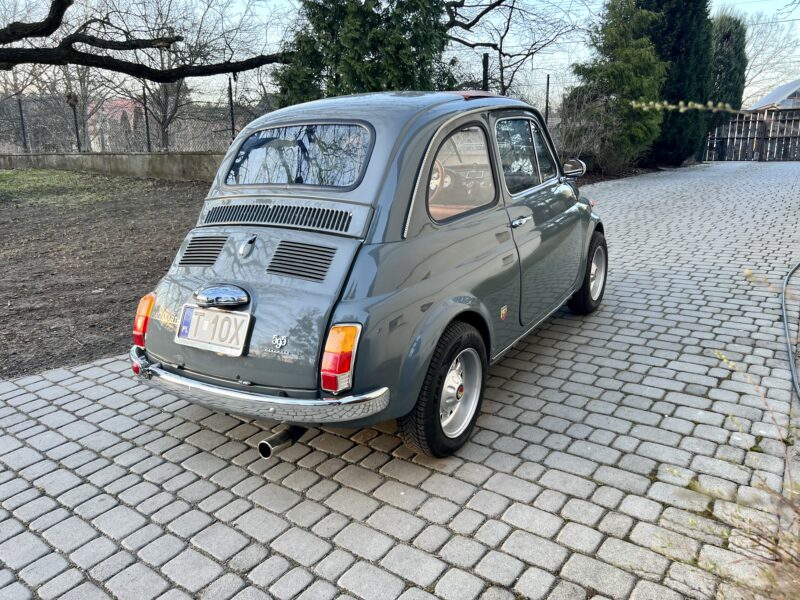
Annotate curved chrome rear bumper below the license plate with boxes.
[130,346,389,425]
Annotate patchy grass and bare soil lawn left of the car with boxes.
[0,170,208,379]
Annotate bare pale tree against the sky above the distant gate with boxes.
[742,12,800,106]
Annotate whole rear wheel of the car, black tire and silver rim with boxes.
[399,321,488,457]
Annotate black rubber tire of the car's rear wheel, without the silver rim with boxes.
[398,321,488,458]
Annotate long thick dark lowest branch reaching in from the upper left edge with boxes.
[0,46,290,83]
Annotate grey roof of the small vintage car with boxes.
[247,91,529,130]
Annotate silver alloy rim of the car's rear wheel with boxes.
[439,348,483,438]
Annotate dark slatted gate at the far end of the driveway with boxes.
[704,108,800,161]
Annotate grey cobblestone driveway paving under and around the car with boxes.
[0,163,800,600]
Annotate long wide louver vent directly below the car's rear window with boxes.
[203,204,353,233]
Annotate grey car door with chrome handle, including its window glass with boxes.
[495,113,583,325]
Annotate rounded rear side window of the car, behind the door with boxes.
[428,125,495,221]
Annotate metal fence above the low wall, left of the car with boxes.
[0,88,271,154]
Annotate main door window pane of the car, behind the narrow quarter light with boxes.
[496,119,541,194]
